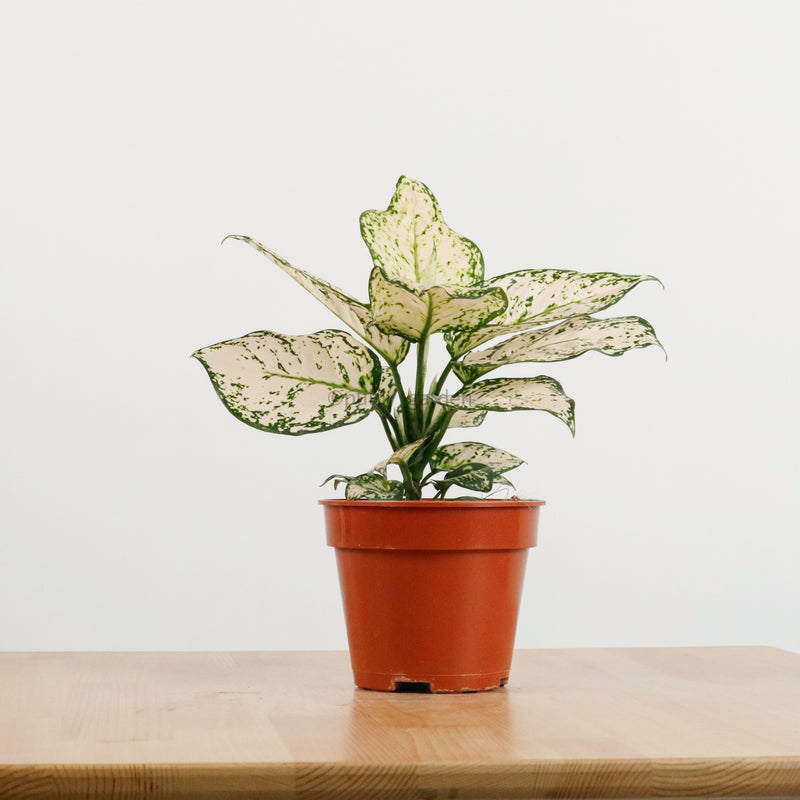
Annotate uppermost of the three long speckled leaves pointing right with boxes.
[445,269,658,355]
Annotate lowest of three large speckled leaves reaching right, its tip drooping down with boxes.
[431,375,575,433]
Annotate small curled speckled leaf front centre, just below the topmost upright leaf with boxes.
[369,267,506,341]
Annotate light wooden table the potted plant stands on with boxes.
[0,647,800,800]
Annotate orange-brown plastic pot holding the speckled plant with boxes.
[320,500,544,692]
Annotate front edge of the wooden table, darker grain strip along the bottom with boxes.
[0,754,800,800]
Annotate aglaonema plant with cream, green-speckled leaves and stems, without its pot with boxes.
[194,177,660,500]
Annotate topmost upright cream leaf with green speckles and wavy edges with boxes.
[361,176,483,287]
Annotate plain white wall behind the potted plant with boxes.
[0,0,800,651]
